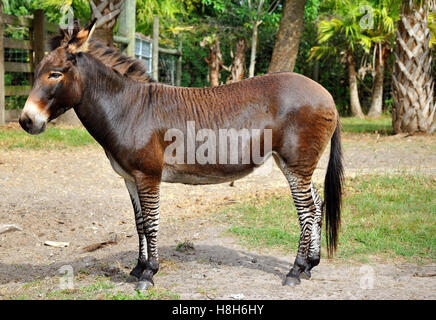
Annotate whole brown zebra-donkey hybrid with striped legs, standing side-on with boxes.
[19,24,343,289]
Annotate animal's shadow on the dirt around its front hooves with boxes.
[0,245,290,284]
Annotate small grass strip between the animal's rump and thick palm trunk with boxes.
[341,116,392,134]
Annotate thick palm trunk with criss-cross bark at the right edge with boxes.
[392,2,436,133]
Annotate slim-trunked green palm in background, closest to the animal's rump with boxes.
[309,0,372,118]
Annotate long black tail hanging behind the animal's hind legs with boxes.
[324,118,344,257]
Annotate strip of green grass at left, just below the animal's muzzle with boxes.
[0,126,96,149]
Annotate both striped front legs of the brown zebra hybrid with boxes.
[126,179,159,290]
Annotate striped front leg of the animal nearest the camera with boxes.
[137,180,160,290]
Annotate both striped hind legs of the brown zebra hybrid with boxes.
[275,155,322,285]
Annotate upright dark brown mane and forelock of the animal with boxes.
[50,22,155,82]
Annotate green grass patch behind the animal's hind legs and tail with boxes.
[224,175,436,262]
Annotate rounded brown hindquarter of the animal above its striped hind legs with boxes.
[275,75,338,176]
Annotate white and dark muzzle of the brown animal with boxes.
[19,98,49,134]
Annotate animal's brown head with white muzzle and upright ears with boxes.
[19,20,95,134]
